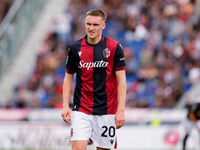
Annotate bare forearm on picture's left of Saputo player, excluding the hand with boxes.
[63,75,73,107]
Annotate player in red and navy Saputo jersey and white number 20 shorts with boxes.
[61,9,126,150]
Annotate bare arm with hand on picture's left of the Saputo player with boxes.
[61,72,74,123]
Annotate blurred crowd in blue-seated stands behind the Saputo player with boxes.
[6,0,200,108]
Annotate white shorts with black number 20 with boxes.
[70,111,117,149]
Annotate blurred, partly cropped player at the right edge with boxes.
[183,102,200,150]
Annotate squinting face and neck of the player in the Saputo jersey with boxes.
[85,16,106,44]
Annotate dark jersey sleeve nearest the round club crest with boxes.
[114,43,126,71]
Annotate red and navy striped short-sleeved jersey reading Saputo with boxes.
[66,36,126,115]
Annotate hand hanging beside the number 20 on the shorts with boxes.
[115,110,125,129]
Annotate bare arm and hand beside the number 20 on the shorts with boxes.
[115,70,126,129]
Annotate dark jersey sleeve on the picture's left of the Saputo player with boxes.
[66,46,76,74]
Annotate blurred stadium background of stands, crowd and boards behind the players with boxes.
[0,0,200,150]
